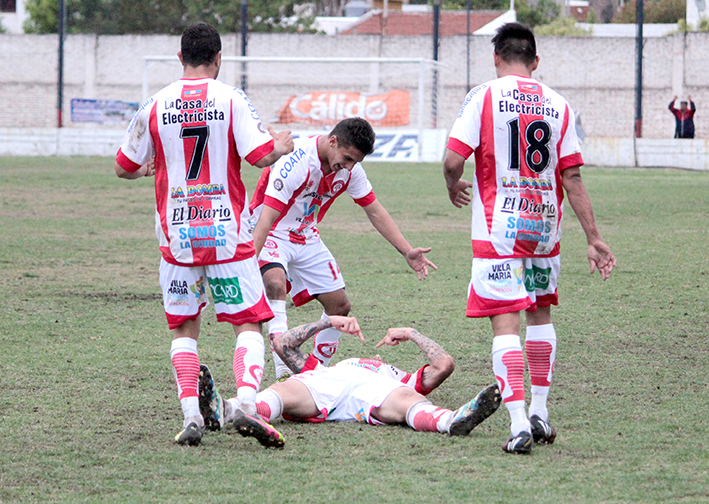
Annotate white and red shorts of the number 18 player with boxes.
[466,255,561,317]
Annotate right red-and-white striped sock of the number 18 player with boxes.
[524,324,556,420]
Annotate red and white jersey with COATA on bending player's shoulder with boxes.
[251,136,376,244]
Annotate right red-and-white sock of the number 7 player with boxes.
[233,331,265,415]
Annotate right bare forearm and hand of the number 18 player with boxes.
[561,166,616,280]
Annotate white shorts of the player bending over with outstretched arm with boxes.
[259,236,345,306]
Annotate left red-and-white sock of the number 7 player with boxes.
[170,338,204,426]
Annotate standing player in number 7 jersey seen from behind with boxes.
[115,23,293,445]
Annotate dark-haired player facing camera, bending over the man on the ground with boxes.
[251,117,436,379]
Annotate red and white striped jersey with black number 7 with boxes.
[116,78,274,266]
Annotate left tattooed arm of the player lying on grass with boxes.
[269,315,364,373]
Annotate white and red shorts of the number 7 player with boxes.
[160,257,273,329]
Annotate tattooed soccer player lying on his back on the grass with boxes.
[199,316,501,445]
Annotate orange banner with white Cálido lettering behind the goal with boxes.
[278,89,409,127]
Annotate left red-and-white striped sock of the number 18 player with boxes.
[492,334,531,436]
